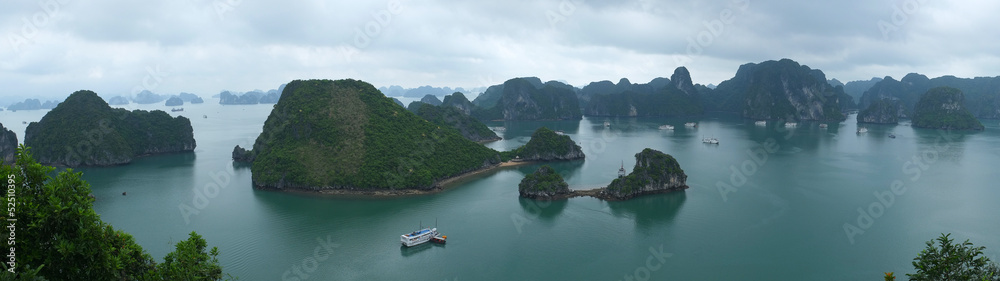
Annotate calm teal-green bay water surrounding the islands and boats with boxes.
[0,100,1000,280]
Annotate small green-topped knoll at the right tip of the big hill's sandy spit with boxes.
[500,127,586,161]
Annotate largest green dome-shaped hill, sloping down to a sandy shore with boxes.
[235,79,500,190]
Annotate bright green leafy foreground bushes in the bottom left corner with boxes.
[0,146,223,281]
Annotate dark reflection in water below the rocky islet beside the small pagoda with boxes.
[607,191,687,231]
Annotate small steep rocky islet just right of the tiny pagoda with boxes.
[601,148,688,200]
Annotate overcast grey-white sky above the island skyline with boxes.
[0,0,1000,105]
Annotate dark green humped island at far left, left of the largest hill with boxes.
[24,91,196,167]
